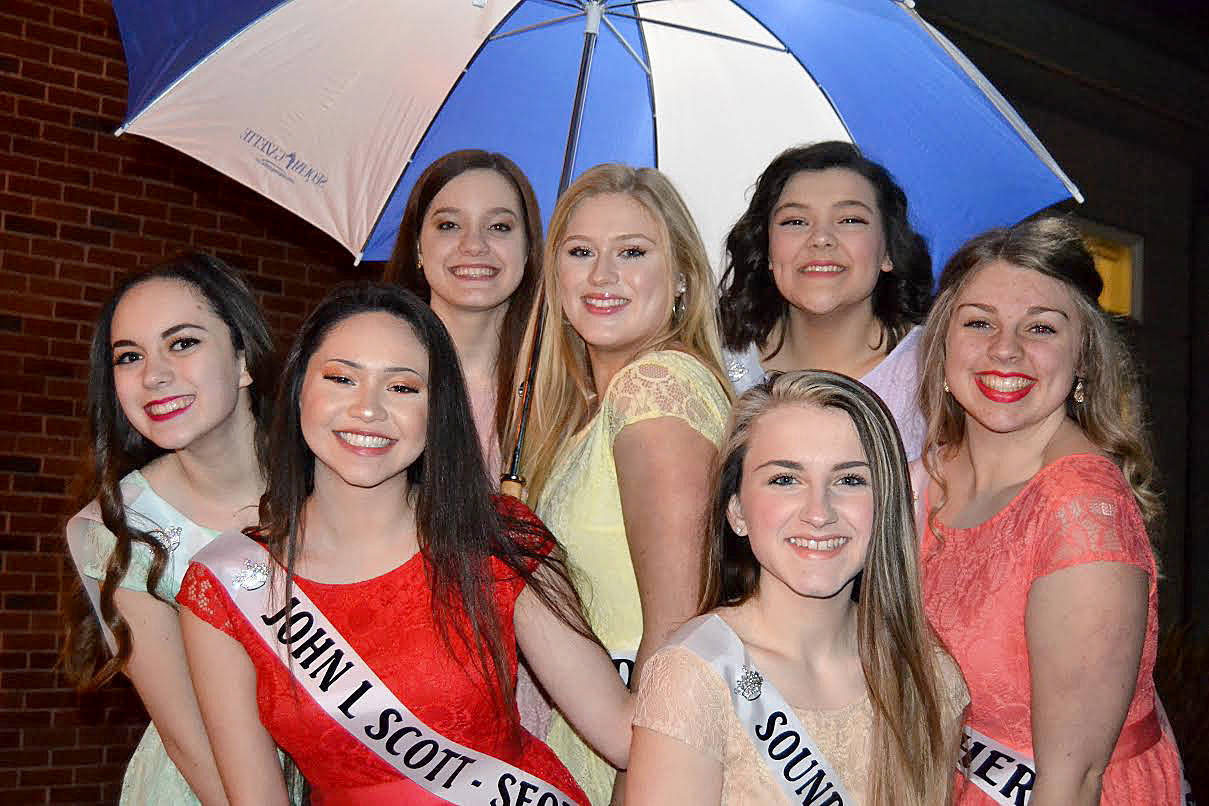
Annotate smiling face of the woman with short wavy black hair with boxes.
[768,168,891,317]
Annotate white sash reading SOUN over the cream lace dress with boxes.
[669,614,856,806]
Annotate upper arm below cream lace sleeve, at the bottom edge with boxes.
[625,725,722,806]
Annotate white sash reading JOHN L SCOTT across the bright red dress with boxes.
[193,532,575,806]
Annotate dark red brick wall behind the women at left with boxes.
[0,0,374,804]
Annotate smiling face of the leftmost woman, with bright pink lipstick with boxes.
[110,279,251,451]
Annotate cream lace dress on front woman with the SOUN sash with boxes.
[634,646,970,806]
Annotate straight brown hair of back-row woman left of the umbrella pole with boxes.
[382,149,542,456]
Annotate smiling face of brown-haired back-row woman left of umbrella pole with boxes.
[420,168,528,314]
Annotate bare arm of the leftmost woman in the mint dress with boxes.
[114,587,227,806]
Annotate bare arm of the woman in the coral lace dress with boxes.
[1025,562,1150,806]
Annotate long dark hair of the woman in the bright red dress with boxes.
[259,283,595,736]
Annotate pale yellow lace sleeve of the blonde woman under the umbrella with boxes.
[603,350,729,443]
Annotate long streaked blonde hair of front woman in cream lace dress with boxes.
[700,370,960,806]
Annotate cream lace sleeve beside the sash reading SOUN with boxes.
[634,646,733,761]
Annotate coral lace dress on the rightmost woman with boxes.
[921,454,1182,806]
